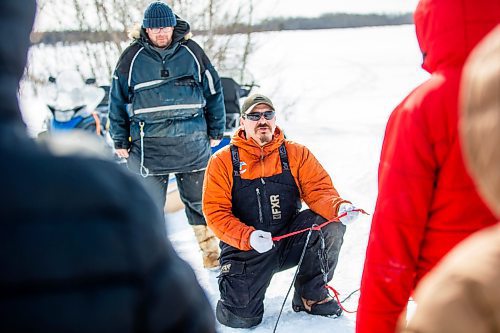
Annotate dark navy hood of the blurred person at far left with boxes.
[0,0,36,123]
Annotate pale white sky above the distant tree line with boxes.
[254,0,418,20]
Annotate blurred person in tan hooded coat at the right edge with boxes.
[400,25,500,333]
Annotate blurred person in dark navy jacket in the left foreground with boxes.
[0,0,215,333]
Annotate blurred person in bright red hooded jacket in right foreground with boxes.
[356,0,500,333]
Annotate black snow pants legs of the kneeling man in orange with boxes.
[216,209,346,328]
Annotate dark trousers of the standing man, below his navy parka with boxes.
[145,170,207,225]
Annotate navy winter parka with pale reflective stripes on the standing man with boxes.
[109,18,225,175]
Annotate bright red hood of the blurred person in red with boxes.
[414,0,500,73]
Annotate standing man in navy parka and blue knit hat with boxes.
[109,1,225,268]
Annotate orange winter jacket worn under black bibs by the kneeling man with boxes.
[203,127,348,250]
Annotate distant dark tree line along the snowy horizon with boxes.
[31,13,413,45]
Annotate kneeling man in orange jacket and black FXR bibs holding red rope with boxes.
[203,94,358,328]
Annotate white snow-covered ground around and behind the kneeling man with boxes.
[20,26,427,333]
